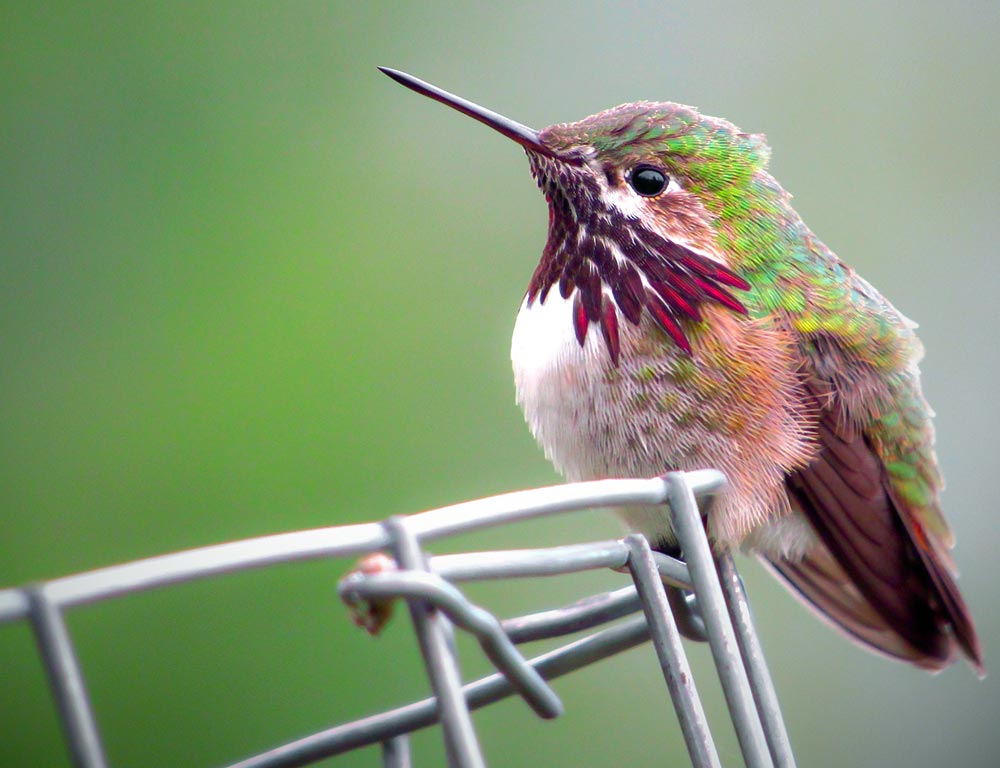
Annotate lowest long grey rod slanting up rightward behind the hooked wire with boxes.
[223,616,649,768]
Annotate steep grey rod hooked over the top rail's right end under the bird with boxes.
[665,472,771,768]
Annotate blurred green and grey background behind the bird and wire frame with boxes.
[0,0,1000,768]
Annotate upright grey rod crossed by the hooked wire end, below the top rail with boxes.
[385,517,486,768]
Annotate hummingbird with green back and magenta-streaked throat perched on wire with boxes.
[380,67,983,674]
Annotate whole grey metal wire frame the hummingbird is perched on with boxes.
[0,470,795,768]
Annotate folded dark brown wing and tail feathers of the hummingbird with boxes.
[774,384,982,672]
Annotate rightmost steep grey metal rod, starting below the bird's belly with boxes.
[715,552,795,768]
